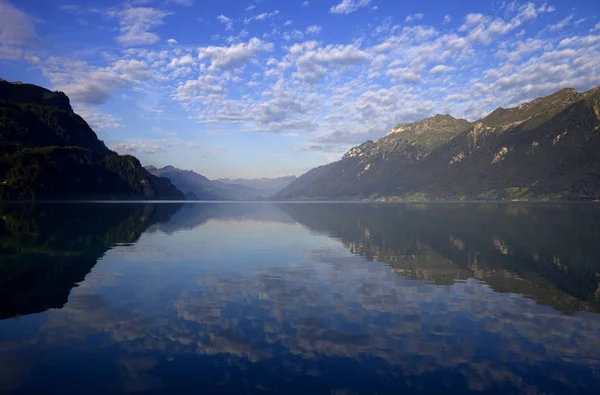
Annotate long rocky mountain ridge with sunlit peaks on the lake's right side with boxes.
[275,87,600,200]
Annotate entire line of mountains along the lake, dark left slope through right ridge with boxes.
[0,79,600,201]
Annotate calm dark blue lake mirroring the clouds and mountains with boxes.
[0,204,600,394]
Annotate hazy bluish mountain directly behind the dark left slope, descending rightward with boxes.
[146,166,260,200]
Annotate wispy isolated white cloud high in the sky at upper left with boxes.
[109,7,170,46]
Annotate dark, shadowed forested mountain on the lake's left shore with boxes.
[0,79,184,200]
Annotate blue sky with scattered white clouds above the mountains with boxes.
[0,0,600,179]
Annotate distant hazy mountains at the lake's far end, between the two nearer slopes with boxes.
[145,166,296,200]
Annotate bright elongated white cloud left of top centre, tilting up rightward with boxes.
[198,38,273,71]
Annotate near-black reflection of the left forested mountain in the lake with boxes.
[0,204,181,319]
